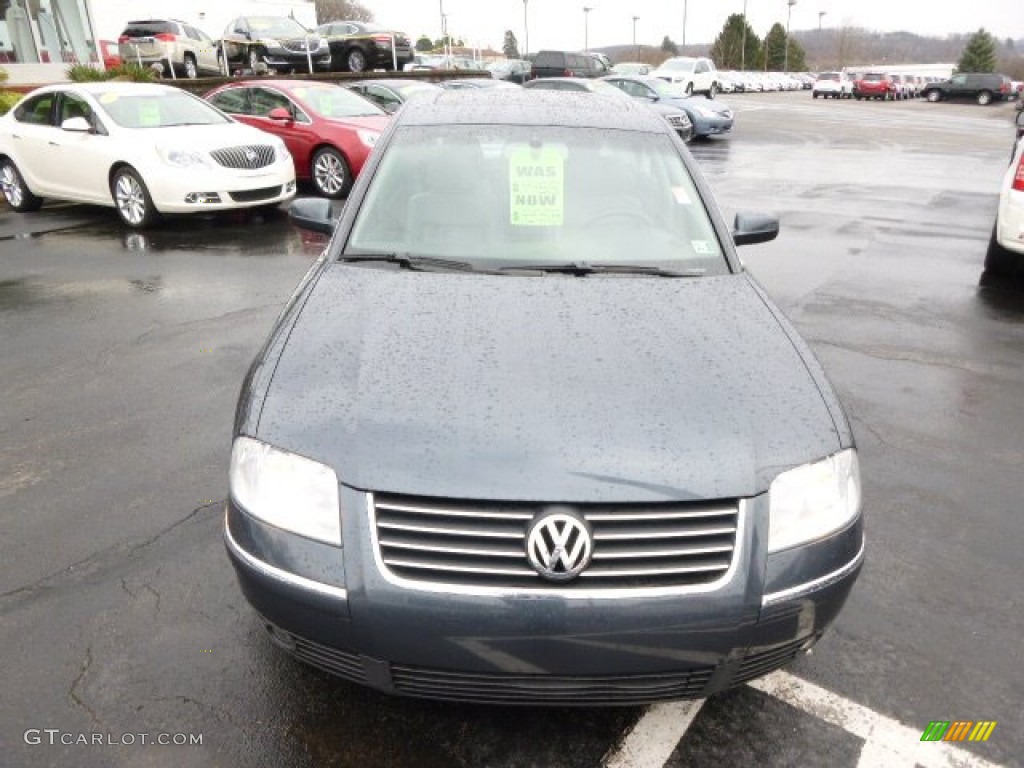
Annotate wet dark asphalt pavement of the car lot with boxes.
[0,93,1024,768]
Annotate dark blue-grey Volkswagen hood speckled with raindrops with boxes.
[257,264,841,502]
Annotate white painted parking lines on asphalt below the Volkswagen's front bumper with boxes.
[602,672,1004,768]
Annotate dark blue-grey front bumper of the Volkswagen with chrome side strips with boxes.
[224,487,864,706]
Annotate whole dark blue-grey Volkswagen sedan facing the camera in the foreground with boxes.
[224,91,863,705]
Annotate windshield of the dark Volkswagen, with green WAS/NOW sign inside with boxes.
[342,125,728,274]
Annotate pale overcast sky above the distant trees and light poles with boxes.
[362,0,1024,50]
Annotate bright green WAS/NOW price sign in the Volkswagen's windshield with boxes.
[509,146,565,226]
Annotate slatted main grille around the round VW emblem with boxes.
[371,496,740,593]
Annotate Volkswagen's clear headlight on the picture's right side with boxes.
[768,449,860,552]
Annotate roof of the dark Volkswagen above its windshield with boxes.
[397,88,670,133]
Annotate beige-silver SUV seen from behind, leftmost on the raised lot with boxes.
[118,18,222,78]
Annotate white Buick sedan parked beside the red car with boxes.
[0,82,295,229]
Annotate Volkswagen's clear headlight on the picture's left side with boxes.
[229,437,341,546]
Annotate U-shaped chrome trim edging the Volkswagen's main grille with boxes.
[366,492,749,600]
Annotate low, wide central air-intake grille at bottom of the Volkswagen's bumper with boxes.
[391,664,715,706]
